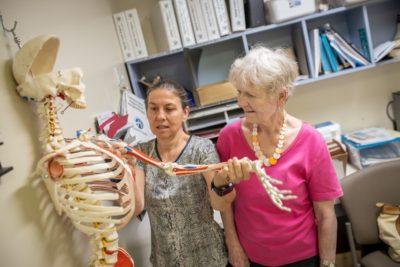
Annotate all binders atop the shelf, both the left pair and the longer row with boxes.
[114,0,266,56]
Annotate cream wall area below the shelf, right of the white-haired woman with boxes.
[287,63,400,132]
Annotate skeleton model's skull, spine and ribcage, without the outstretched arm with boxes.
[13,36,134,267]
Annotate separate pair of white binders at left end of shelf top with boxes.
[113,8,148,62]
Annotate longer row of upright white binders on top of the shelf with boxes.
[151,0,241,52]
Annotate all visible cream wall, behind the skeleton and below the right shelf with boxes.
[0,0,400,267]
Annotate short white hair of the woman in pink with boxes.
[229,46,298,96]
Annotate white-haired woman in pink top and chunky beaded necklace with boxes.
[213,47,343,267]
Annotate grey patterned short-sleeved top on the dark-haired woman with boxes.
[138,136,228,267]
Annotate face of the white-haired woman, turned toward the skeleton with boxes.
[237,87,278,123]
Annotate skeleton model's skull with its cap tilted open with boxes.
[13,35,86,108]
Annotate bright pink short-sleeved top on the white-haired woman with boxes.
[217,120,343,266]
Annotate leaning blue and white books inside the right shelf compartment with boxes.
[310,24,370,77]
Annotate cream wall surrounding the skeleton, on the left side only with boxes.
[0,0,150,267]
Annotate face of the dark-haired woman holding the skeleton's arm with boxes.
[147,89,189,139]
